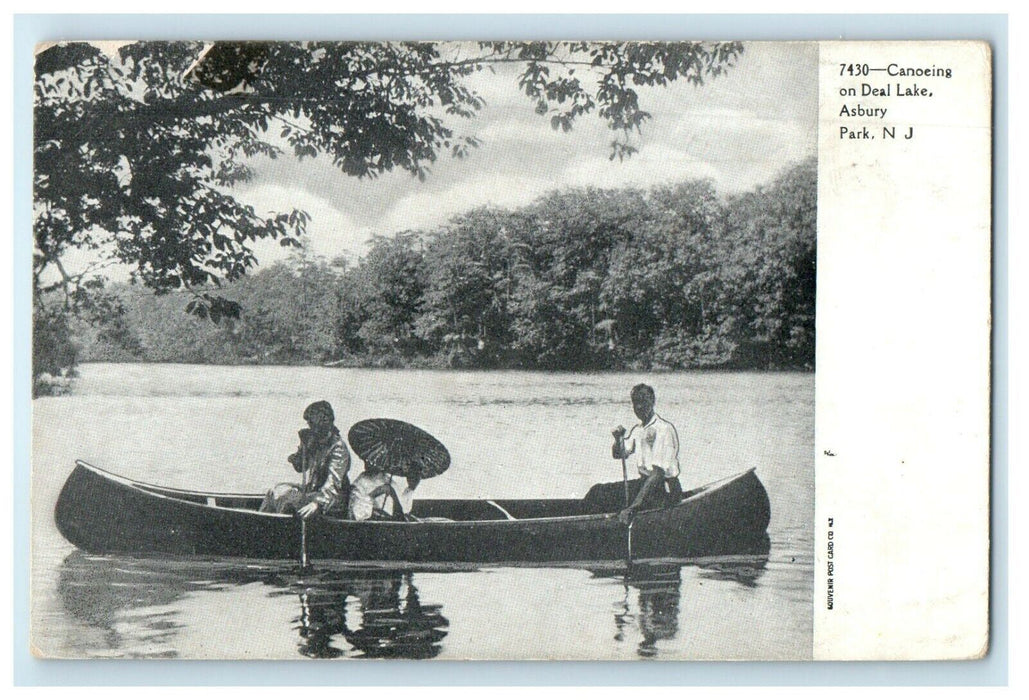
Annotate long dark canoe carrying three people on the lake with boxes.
[55,461,770,565]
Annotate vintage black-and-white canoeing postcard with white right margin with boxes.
[31,41,992,660]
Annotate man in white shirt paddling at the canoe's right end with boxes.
[611,384,682,523]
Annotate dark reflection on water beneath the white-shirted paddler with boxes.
[594,556,768,658]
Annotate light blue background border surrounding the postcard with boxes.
[12,14,1008,686]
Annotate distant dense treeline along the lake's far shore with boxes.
[75,160,817,370]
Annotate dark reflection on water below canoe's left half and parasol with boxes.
[58,551,450,659]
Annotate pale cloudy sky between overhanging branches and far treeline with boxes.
[235,42,818,265]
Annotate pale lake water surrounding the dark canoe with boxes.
[31,364,814,659]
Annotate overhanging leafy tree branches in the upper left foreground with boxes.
[33,41,742,382]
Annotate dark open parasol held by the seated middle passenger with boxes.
[347,418,450,479]
